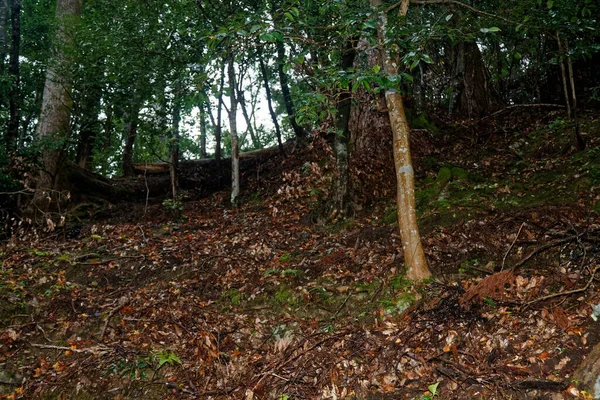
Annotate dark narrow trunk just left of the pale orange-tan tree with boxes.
[330,38,356,219]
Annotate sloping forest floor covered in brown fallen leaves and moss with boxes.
[0,108,600,400]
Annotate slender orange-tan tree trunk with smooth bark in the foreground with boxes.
[370,0,431,280]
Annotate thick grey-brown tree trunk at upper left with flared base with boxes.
[33,0,81,216]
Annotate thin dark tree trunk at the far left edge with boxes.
[6,0,21,151]
